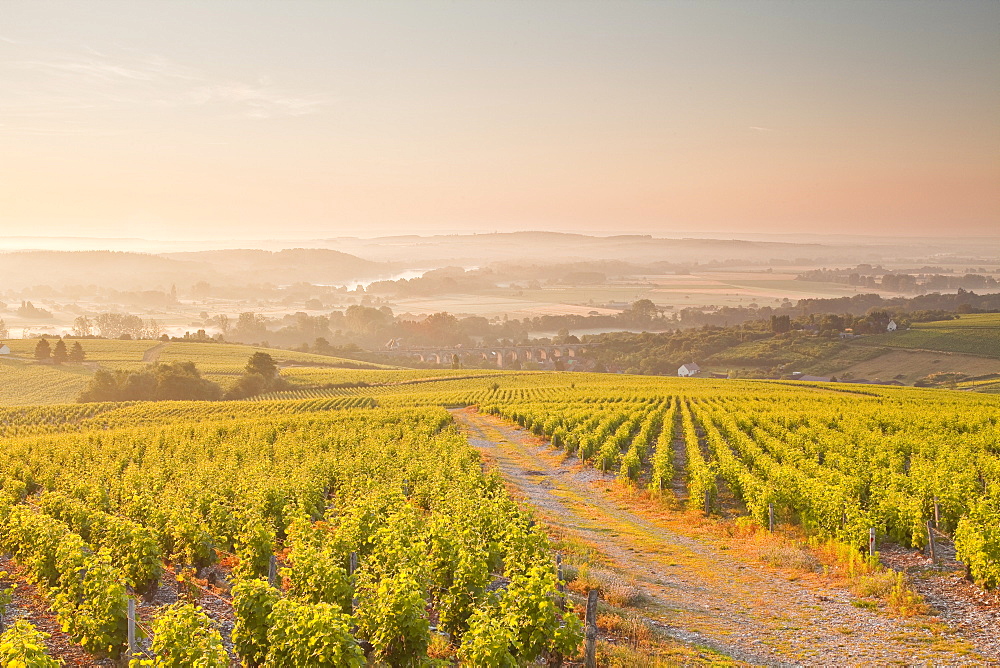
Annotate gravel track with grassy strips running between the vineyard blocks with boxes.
[452,409,989,665]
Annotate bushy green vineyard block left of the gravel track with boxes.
[0,407,581,666]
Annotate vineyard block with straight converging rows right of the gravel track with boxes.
[482,382,1000,587]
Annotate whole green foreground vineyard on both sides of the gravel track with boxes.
[0,370,1000,666]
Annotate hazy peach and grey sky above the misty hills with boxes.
[0,0,1000,239]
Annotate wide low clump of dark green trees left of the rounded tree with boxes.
[77,362,222,403]
